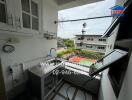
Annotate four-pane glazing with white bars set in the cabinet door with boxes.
[21,0,39,30]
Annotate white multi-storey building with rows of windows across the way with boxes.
[75,35,108,53]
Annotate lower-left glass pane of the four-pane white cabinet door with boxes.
[22,13,31,28]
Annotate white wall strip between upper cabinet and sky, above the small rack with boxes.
[42,0,58,33]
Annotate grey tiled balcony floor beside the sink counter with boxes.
[50,83,93,100]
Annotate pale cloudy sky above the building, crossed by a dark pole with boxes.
[58,0,115,38]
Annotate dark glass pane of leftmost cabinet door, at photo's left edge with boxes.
[0,3,6,23]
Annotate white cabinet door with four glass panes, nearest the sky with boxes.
[14,0,40,34]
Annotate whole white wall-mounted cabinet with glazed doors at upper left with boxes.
[0,0,41,34]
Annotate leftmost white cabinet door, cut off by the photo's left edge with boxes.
[0,0,14,31]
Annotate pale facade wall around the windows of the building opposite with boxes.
[75,36,108,53]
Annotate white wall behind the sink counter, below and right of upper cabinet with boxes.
[0,0,58,95]
